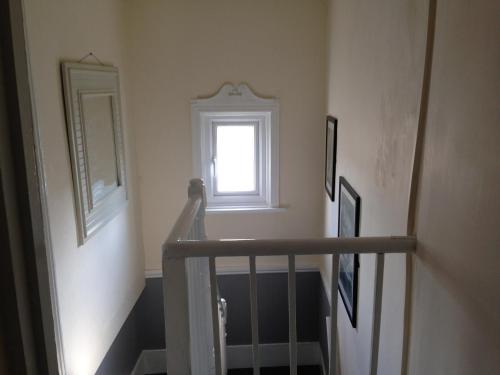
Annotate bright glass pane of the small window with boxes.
[216,125,256,193]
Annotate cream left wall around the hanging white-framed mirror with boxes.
[24,0,144,375]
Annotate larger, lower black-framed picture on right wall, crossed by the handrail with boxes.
[338,177,361,328]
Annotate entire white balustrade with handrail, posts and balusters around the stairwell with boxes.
[163,179,416,375]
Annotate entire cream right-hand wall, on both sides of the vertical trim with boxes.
[323,0,500,375]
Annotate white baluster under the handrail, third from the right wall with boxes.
[288,255,297,375]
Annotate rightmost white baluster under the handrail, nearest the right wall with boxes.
[370,253,384,375]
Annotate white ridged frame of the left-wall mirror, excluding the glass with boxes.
[61,62,127,246]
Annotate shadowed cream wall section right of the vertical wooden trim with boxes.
[410,0,500,375]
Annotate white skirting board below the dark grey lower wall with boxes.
[131,342,325,375]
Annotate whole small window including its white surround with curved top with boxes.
[191,84,278,210]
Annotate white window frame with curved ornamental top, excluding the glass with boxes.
[191,84,279,211]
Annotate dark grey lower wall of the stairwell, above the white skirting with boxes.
[97,271,330,375]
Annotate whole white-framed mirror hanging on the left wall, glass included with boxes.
[61,62,127,245]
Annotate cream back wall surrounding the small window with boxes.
[126,0,326,271]
